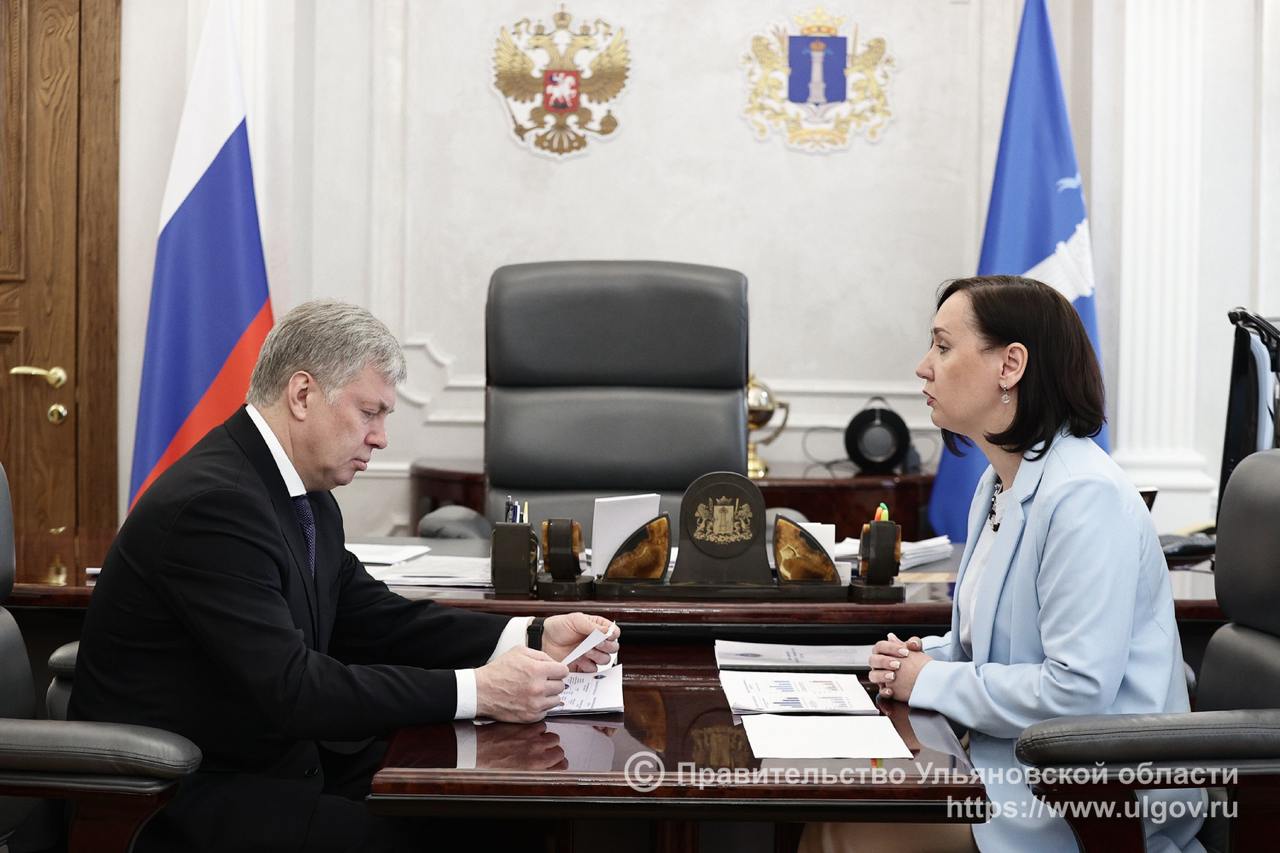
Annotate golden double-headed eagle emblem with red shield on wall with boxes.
[493,6,631,156]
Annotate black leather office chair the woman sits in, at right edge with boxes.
[1018,451,1280,853]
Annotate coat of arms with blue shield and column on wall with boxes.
[742,8,893,152]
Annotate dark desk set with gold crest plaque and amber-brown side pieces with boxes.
[596,471,849,601]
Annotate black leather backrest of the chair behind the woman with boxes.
[1196,450,1280,711]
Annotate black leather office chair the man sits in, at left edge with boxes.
[0,467,201,853]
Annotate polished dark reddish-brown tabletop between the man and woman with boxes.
[370,645,986,822]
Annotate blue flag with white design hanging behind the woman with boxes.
[929,0,1110,542]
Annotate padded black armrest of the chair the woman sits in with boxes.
[1015,708,1280,775]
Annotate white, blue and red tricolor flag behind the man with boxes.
[129,0,271,508]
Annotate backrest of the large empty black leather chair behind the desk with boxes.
[485,261,748,535]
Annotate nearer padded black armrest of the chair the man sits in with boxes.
[0,720,202,779]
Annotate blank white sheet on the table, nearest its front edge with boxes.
[742,713,911,758]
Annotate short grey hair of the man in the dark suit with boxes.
[247,300,406,409]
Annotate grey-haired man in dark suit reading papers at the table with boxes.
[69,301,617,850]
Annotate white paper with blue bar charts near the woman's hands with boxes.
[721,671,879,713]
